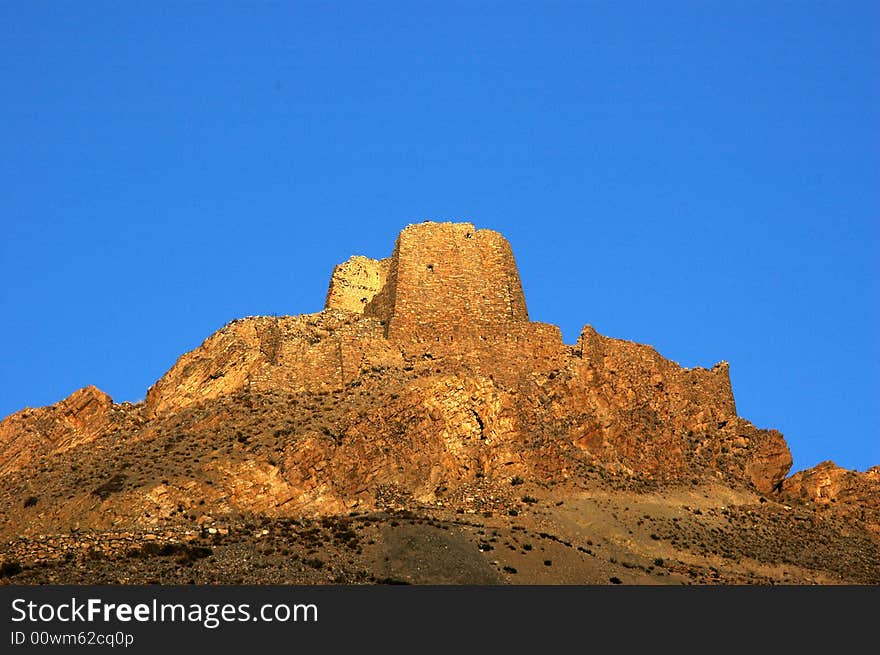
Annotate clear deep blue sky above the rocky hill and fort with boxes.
[0,0,880,469]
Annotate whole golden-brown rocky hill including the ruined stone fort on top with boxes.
[0,222,880,583]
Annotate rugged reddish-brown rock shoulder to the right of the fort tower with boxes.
[554,326,792,492]
